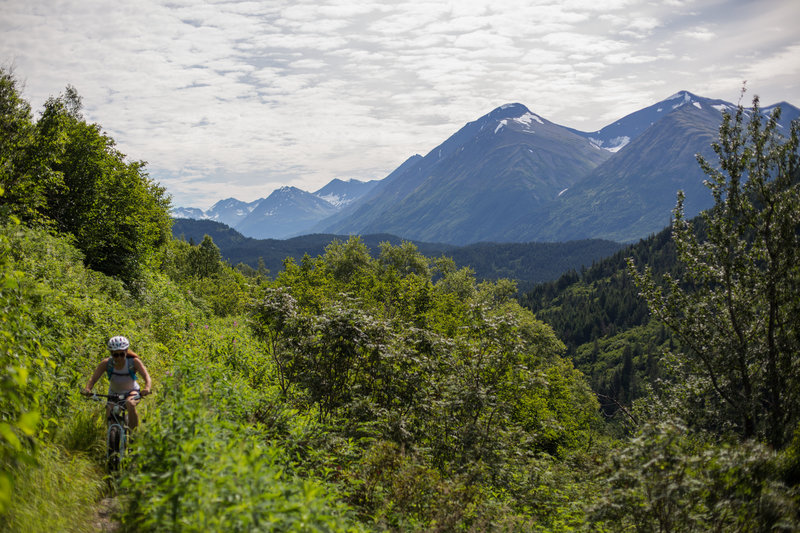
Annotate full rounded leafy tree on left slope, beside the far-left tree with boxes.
[37,87,171,282]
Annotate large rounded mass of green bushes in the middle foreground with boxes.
[251,238,598,530]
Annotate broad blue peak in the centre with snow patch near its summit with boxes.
[315,104,611,244]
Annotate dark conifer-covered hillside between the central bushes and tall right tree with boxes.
[520,224,684,416]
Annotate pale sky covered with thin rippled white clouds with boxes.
[0,0,800,209]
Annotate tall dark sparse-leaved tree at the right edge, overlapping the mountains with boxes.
[629,93,800,447]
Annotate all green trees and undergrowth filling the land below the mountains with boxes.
[0,67,800,532]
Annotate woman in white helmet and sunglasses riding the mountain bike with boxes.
[82,336,152,429]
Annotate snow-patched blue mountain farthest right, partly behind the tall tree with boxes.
[516,91,800,242]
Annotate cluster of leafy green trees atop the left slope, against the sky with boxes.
[0,70,171,284]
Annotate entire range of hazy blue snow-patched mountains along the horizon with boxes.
[174,91,800,245]
